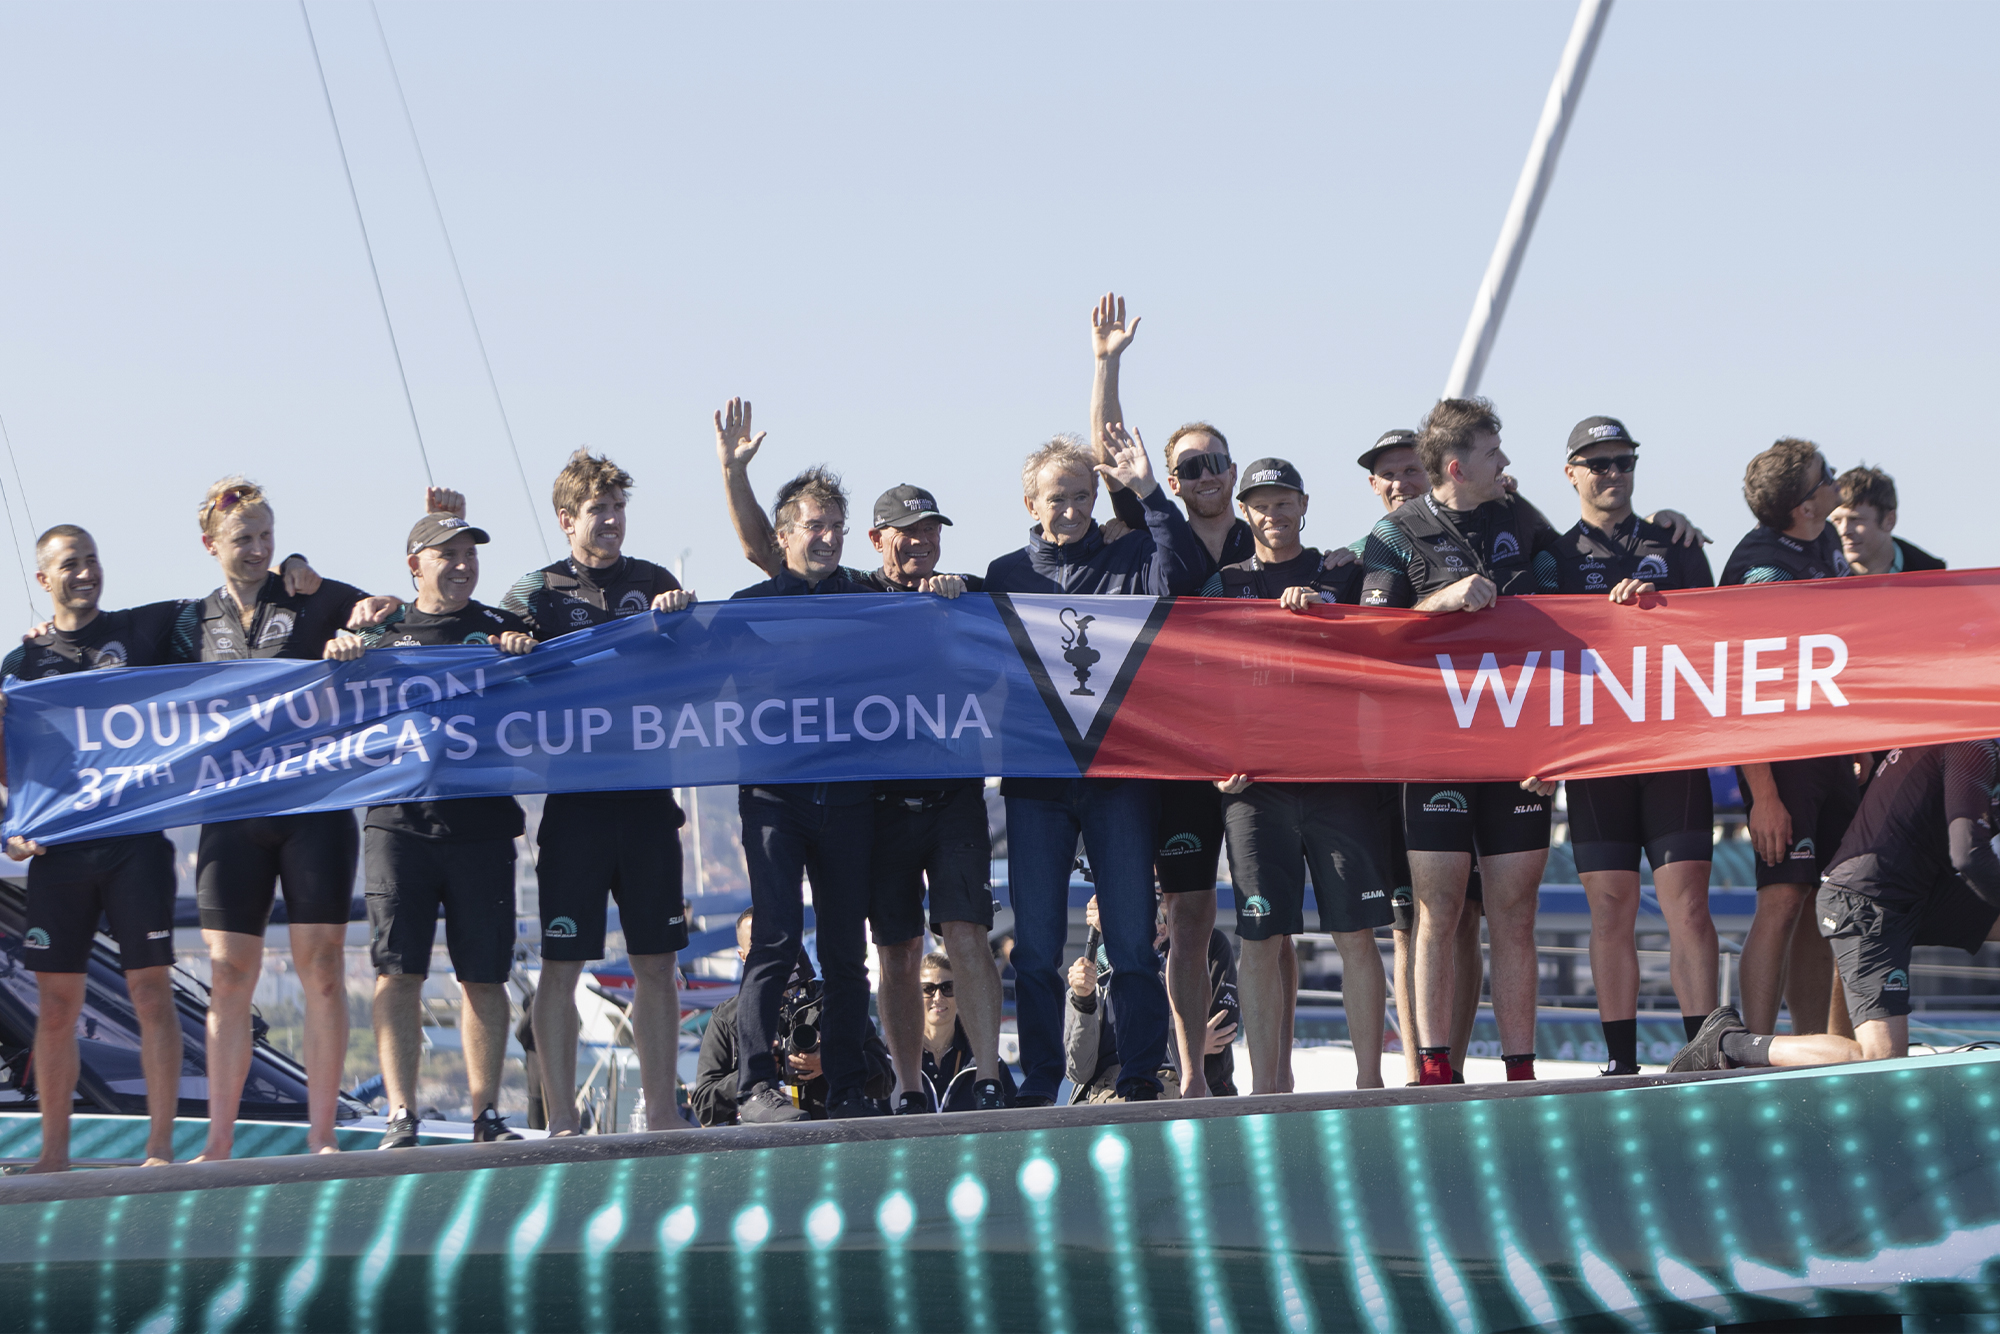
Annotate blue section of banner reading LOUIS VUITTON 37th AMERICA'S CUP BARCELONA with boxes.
[6,594,1078,844]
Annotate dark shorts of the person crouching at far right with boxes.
[1814,858,2000,1024]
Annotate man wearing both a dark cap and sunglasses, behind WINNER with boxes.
[1556,416,1716,1074]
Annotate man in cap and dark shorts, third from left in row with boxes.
[326,512,540,1148]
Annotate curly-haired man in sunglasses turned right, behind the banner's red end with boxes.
[1722,438,1860,1034]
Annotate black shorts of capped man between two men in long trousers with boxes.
[868,784,994,944]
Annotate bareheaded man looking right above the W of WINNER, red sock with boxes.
[1362,398,1556,1084]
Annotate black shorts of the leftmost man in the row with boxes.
[20,834,174,972]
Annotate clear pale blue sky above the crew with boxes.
[0,0,2000,624]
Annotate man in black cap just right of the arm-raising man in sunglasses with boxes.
[1204,458,1394,1094]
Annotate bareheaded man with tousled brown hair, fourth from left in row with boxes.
[500,450,694,1136]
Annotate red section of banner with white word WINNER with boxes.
[1090,570,2000,782]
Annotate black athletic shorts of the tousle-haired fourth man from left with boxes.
[534,792,688,962]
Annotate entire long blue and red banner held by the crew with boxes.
[6,570,2000,842]
